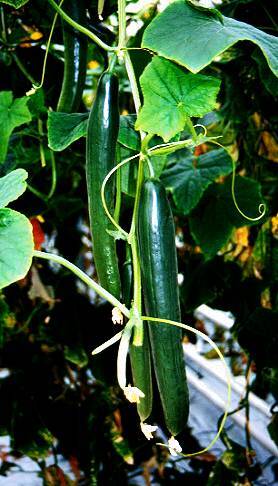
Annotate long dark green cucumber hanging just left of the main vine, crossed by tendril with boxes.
[86,72,121,298]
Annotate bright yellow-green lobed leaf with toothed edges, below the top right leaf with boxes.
[135,56,220,142]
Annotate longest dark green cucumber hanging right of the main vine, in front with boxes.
[138,179,189,435]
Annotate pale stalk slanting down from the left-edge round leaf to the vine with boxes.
[33,250,130,319]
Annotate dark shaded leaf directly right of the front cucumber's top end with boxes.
[162,149,232,215]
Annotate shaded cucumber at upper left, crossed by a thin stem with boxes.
[57,0,88,113]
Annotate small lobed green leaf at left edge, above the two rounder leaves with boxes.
[0,91,32,163]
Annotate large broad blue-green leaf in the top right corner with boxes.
[142,1,278,76]
